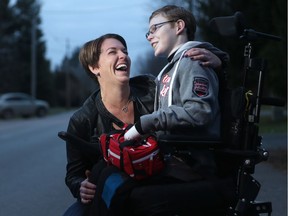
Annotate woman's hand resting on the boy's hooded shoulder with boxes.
[185,48,222,69]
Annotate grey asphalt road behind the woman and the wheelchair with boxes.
[0,112,287,216]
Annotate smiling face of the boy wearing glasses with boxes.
[147,15,177,57]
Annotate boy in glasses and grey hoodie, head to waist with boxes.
[125,5,220,175]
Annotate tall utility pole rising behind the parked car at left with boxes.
[31,17,37,98]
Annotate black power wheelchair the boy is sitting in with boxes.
[58,12,284,216]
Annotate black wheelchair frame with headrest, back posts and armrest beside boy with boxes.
[159,12,285,216]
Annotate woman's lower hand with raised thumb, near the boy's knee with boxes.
[80,170,96,204]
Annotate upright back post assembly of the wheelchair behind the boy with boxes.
[211,12,284,216]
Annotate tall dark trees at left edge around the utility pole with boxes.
[0,0,53,101]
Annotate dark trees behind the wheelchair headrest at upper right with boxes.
[198,0,287,98]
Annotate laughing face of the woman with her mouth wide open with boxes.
[95,38,131,84]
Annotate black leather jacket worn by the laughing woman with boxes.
[65,75,155,198]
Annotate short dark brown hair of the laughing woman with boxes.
[79,33,127,82]
